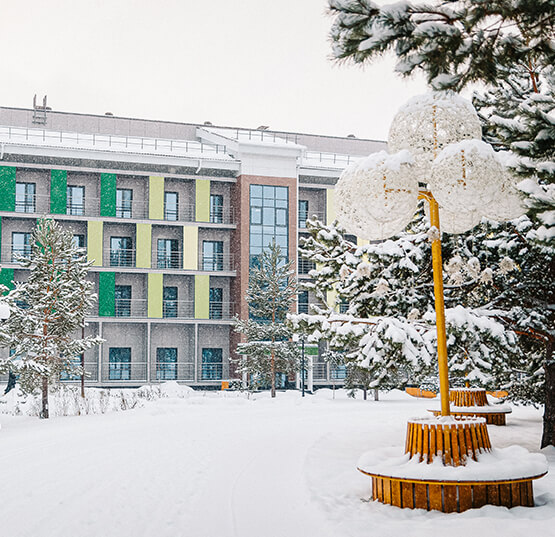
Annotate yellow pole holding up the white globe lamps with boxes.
[420,192,451,416]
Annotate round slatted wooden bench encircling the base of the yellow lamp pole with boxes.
[358,416,547,513]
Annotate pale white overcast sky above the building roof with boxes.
[0,0,425,139]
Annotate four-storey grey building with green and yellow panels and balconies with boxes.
[0,107,384,387]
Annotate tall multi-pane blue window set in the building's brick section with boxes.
[249,185,289,266]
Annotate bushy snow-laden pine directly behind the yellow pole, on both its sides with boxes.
[292,215,521,389]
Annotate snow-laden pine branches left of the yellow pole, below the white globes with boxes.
[292,215,434,389]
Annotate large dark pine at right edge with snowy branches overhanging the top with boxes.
[329,0,555,446]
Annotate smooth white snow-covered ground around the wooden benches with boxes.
[0,390,555,537]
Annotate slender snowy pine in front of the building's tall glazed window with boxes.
[235,242,300,397]
